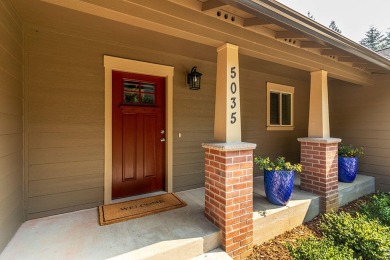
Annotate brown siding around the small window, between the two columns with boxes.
[240,65,309,174]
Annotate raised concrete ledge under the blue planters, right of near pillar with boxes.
[253,174,375,244]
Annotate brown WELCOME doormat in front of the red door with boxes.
[99,193,187,225]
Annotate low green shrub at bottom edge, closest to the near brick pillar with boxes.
[287,238,354,260]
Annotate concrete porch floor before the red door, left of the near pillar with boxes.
[0,189,220,259]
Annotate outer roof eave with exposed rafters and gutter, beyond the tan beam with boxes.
[200,0,390,73]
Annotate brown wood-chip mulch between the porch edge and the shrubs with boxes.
[246,195,372,260]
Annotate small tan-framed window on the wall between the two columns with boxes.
[267,82,294,130]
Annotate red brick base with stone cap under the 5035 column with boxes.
[203,143,256,259]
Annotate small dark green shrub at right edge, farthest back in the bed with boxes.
[360,192,390,226]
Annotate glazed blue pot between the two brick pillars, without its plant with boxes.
[264,170,294,206]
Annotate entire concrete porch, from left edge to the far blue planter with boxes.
[0,175,375,260]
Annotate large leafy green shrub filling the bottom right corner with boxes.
[320,212,390,260]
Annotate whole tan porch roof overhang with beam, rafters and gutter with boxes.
[12,0,390,85]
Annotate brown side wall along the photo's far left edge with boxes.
[0,0,23,252]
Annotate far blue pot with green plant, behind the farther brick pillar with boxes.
[338,144,364,183]
